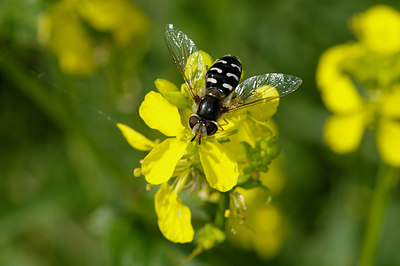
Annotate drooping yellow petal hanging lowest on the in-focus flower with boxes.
[154,183,194,243]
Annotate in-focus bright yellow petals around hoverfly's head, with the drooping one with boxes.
[117,89,238,243]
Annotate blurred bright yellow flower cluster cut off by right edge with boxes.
[316,5,400,166]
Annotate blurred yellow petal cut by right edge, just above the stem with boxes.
[377,120,400,167]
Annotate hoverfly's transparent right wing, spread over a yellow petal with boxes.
[225,73,302,112]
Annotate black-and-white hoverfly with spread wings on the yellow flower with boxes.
[164,24,302,144]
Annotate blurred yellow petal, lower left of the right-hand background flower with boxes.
[324,113,365,154]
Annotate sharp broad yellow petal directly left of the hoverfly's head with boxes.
[139,91,185,137]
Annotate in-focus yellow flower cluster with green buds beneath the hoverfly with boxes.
[118,52,279,256]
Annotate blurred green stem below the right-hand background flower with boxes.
[360,163,396,266]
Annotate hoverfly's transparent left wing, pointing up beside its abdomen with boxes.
[164,24,207,99]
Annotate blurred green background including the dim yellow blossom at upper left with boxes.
[0,0,400,265]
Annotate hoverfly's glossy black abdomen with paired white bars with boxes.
[206,55,242,98]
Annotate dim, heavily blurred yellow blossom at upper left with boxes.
[38,0,148,75]
